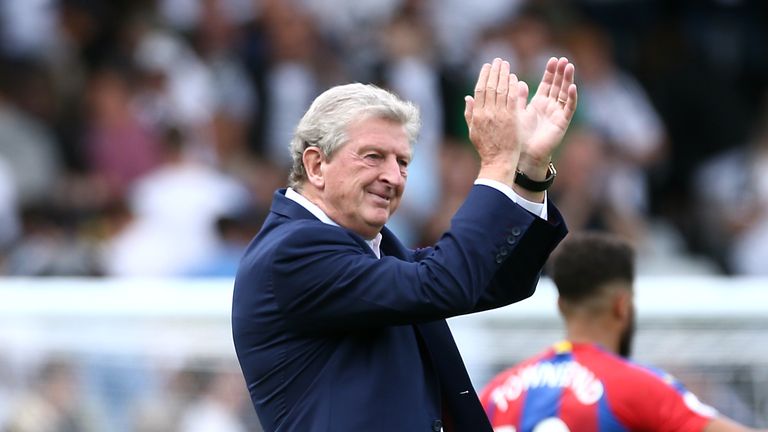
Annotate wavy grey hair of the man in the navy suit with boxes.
[288,83,421,188]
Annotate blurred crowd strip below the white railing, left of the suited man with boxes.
[0,355,261,432]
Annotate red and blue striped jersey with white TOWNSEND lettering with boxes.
[480,341,717,432]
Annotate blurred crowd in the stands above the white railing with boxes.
[0,0,768,276]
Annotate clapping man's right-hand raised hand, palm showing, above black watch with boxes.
[518,57,577,175]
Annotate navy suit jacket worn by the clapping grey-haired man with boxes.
[232,185,566,432]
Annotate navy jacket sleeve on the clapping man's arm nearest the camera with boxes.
[271,185,562,330]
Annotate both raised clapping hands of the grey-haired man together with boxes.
[464,57,577,198]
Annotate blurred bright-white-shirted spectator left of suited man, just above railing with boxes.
[104,129,251,276]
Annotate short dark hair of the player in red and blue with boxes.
[549,231,635,304]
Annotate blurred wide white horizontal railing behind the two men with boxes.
[0,277,768,426]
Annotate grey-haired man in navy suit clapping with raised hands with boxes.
[232,58,576,432]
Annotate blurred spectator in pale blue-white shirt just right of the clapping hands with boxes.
[565,24,667,242]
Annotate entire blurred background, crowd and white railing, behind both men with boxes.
[0,0,768,432]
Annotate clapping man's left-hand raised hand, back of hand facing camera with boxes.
[464,58,525,185]
